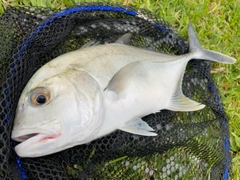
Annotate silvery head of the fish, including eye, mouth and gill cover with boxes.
[12,70,103,157]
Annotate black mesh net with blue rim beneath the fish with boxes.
[0,4,231,180]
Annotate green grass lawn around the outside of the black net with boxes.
[0,0,240,180]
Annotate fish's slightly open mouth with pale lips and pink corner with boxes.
[11,121,62,157]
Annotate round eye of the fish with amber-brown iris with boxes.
[30,88,50,106]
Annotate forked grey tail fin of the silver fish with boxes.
[188,23,236,64]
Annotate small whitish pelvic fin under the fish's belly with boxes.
[119,118,157,136]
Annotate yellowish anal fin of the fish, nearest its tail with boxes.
[167,89,205,111]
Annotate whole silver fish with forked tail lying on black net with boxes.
[11,23,236,158]
